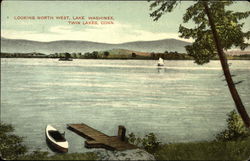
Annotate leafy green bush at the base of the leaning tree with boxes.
[216,110,250,141]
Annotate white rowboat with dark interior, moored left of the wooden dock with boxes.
[45,125,69,153]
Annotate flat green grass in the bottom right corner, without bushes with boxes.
[154,138,250,160]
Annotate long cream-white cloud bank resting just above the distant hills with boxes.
[2,23,192,43]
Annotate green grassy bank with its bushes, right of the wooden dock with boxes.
[128,110,250,161]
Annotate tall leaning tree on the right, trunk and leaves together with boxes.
[150,0,250,128]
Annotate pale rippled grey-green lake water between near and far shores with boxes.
[1,58,250,152]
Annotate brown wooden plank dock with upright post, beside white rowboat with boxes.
[67,123,137,151]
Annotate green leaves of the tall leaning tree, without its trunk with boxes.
[150,0,250,64]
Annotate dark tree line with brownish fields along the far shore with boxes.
[1,51,250,60]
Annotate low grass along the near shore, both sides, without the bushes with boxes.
[15,137,250,161]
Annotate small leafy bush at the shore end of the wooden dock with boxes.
[128,133,160,154]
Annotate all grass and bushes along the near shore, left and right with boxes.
[0,110,250,161]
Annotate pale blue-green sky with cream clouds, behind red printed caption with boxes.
[1,0,250,44]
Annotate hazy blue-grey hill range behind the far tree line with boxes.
[1,38,190,54]
